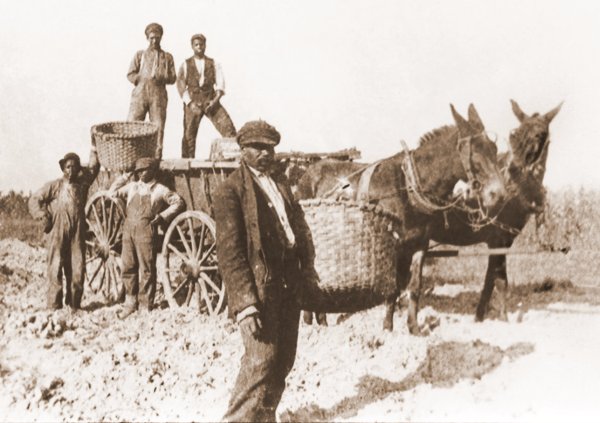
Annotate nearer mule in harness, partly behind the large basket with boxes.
[297,105,506,334]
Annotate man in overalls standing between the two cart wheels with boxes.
[109,158,185,319]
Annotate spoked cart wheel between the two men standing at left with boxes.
[85,191,125,302]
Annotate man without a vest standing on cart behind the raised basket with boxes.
[127,23,176,159]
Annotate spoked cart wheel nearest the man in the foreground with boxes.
[162,210,225,316]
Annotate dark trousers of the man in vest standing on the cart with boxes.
[181,103,235,159]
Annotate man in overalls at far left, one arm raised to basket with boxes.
[29,138,100,310]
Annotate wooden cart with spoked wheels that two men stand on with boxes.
[85,149,360,315]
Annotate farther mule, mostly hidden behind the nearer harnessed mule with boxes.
[426,100,562,321]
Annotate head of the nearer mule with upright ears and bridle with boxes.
[450,104,507,210]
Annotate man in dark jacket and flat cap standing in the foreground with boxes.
[213,121,316,422]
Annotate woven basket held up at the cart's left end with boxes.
[92,121,158,172]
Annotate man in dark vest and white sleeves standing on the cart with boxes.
[177,34,235,158]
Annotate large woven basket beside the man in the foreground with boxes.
[300,199,396,313]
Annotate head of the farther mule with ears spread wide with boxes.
[509,100,562,176]
